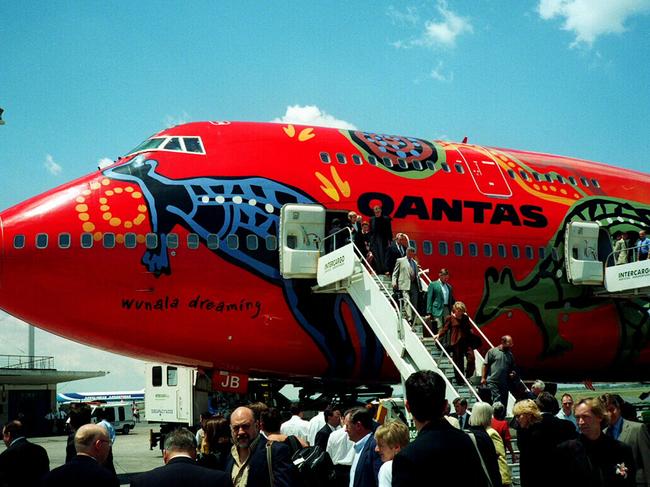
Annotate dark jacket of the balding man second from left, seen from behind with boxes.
[43,455,120,487]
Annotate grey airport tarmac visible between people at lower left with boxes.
[0,422,163,485]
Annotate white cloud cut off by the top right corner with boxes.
[537,0,650,47]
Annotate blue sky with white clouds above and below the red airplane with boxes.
[0,0,650,390]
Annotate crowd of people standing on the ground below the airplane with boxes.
[0,376,650,487]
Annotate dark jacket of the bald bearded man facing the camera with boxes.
[226,436,296,487]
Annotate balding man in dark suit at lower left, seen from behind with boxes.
[43,424,117,487]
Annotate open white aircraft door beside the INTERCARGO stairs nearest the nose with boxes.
[279,204,326,279]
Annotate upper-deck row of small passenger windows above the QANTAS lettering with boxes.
[320,152,600,188]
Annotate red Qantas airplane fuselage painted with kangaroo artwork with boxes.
[0,122,650,383]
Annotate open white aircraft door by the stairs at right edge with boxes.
[564,222,604,286]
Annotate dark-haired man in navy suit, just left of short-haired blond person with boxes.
[348,408,382,487]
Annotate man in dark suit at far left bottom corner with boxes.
[0,421,50,487]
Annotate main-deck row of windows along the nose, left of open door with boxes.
[14,232,278,254]
